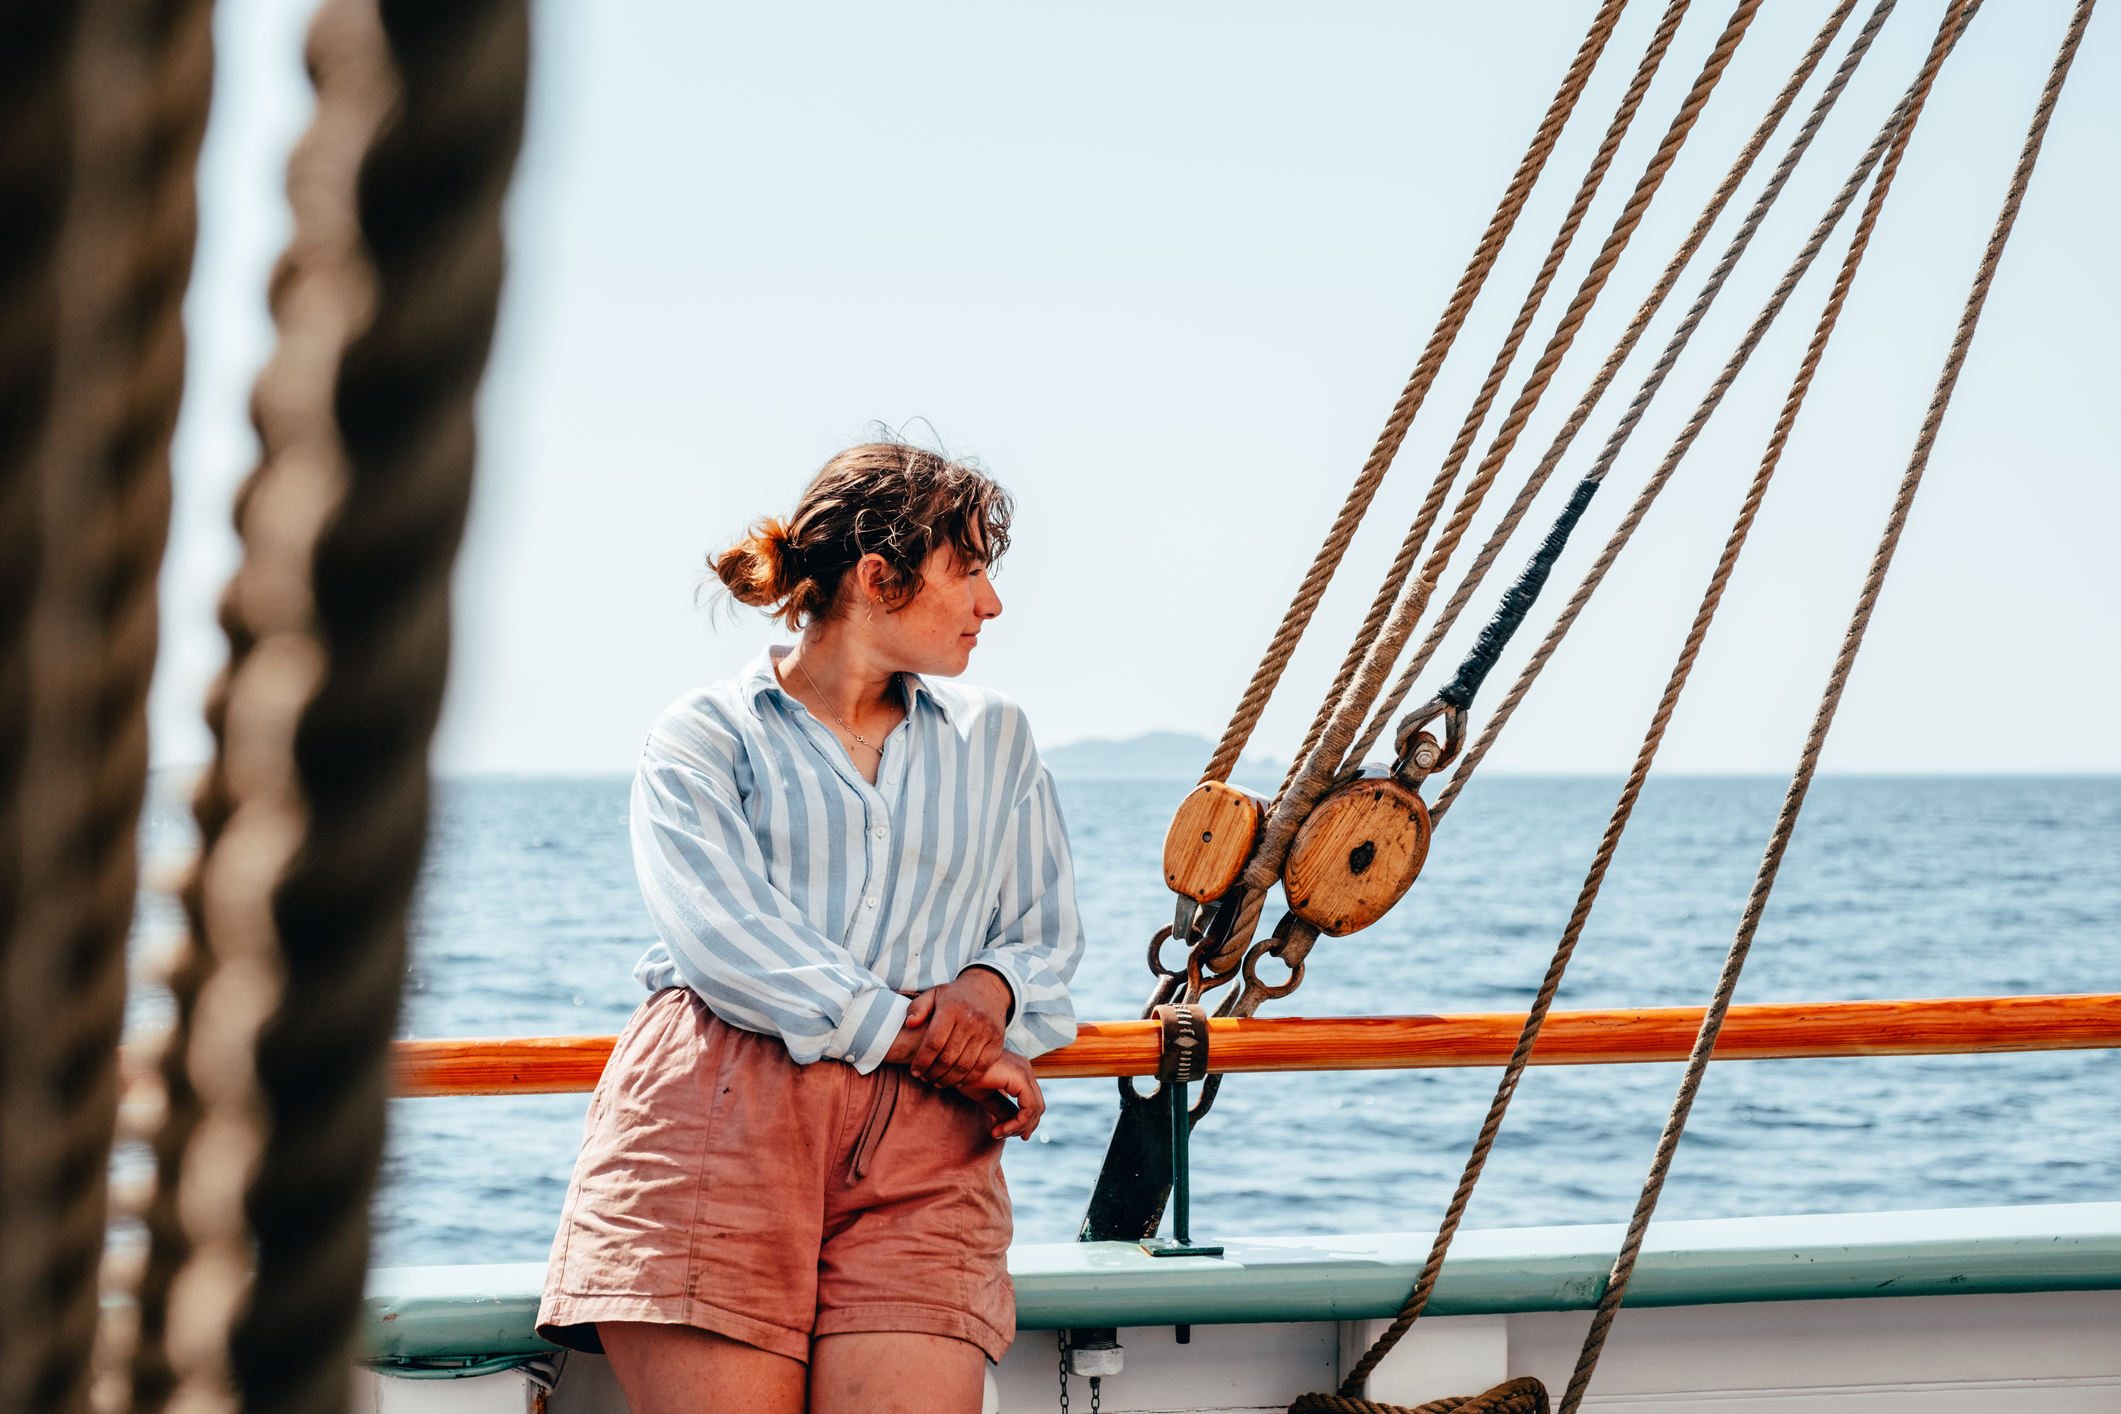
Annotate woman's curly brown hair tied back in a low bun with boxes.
[708,441,1014,630]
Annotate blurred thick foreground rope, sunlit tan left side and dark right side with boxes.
[134,0,528,1414]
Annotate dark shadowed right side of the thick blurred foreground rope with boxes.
[231,0,530,1414]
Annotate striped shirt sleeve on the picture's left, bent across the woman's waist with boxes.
[632,727,912,1073]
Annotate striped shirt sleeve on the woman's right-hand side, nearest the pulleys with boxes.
[969,765,1082,1056]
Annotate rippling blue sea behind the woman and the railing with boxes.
[146,774,2121,1266]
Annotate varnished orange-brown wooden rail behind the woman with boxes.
[397,992,2121,1096]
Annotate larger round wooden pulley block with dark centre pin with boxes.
[1281,765,1430,937]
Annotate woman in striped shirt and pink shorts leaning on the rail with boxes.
[539,443,1082,1414]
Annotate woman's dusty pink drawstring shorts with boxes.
[537,988,1016,1361]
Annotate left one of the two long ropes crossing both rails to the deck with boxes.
[1340,0,1964,1395]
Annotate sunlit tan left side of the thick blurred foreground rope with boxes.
[132,0,395,1414]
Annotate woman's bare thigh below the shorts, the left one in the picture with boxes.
[596,1321,805,1414]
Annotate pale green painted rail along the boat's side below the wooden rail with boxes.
[367,1202,2121,1359]
